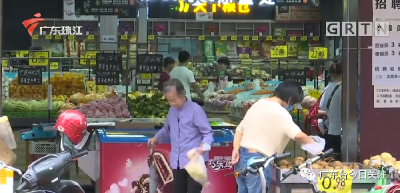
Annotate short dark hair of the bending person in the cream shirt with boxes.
[274,80,304,105]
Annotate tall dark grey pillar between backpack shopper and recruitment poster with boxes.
[342,0,360,162]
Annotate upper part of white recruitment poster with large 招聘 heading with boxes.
[374,0,400,86]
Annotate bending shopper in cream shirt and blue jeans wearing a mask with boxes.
[232,80,325,193]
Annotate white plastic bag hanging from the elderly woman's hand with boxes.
[185,149,208,185]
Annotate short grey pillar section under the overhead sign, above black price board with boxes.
[100,15,118,51]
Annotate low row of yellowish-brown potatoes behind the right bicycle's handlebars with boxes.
[278,157,360,170]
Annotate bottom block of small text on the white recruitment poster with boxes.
[374,85,400,108]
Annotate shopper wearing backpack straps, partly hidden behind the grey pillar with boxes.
[320,61,342,161]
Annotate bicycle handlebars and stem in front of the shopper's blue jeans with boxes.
[225,153,292,193]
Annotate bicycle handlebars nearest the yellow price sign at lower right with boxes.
[281,149,333,193]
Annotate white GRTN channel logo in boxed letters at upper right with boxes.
[325,22,390,36]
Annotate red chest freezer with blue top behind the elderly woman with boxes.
[79,129,236,193]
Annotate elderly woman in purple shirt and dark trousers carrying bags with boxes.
[149,79,214,193]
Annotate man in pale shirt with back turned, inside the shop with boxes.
[170,51,204,100]
